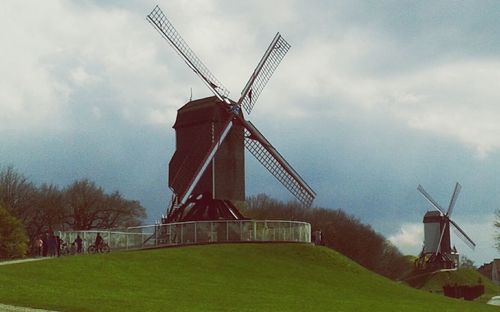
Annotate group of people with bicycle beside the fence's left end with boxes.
[35,231,104,257]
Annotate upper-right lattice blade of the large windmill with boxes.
[238,33,290,114]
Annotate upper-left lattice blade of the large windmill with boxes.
[147,6,229,101]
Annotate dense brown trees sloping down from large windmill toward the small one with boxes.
[243,194,412,279]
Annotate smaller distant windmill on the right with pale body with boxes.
[417,182,476,270]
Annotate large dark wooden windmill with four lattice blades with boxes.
[147,6,316,223]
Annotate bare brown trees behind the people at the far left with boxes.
[0,167,146,257]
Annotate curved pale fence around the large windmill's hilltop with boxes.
[58,220,311,249]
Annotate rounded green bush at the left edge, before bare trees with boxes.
[0,204,28,259]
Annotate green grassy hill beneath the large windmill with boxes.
[0,244,498,312]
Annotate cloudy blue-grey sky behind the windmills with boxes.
[0,0,500,265]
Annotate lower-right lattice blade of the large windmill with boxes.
[243,121,316,207]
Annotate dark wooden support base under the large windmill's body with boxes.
[162,194,248,224]
